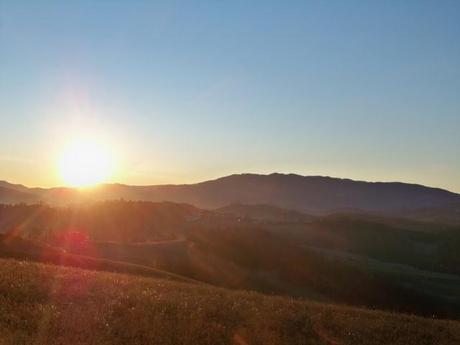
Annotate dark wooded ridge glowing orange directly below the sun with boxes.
[0,201,206,242]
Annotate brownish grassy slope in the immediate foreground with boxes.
[0,259,460,345]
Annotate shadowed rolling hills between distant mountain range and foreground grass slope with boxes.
[0,201,460,318]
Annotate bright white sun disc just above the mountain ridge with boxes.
[58,139,113,187]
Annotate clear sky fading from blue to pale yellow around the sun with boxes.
[0,0,460,192]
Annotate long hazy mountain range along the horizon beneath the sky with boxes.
[0,173,460,222]
